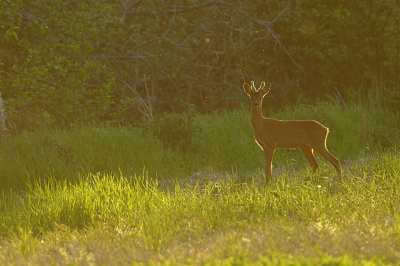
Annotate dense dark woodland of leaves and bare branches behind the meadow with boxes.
[0,0,400,133]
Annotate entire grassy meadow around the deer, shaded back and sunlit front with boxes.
[0,96,400,265]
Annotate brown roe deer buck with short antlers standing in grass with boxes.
[243,81,343,183]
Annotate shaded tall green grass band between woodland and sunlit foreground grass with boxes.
[0,97,400,191]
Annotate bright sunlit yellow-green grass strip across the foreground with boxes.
[0,152,400,265]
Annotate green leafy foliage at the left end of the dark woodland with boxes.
[0,1,124,133]
